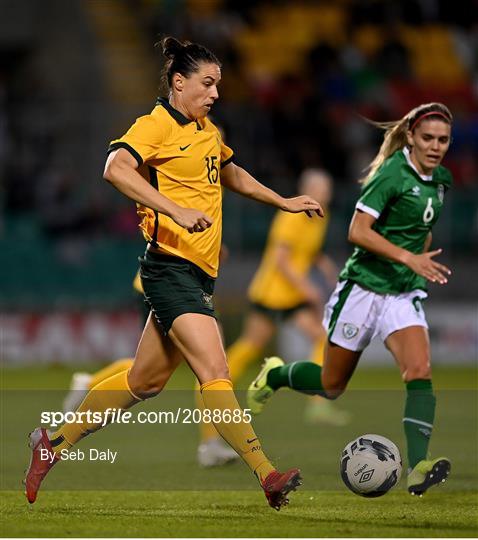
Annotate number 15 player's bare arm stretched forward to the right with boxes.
[221,163,324,217]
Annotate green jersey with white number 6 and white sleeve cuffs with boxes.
[339,148,452,294]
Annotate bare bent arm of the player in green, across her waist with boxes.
[348,210,451,285]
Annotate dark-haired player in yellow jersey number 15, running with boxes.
[25,37,323,510]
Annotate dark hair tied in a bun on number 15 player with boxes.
[157,36,221,89]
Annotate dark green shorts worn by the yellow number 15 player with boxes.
[139,251,216,335]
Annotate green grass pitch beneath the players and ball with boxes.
[0,366,478,537]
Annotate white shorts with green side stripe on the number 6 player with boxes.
[324,281,428,351]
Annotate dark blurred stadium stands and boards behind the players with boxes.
[0,0,478,364]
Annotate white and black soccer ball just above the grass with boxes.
[340,434,402,497]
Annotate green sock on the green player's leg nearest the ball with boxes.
[403,379,436,469]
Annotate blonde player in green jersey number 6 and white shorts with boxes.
[248,103,452,495]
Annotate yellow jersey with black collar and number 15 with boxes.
[108,98,233,278]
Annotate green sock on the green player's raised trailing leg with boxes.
[267,362,325,396]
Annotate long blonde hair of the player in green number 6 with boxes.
[360,103,453,184]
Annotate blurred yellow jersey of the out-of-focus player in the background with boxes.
[248,210,328,309]
